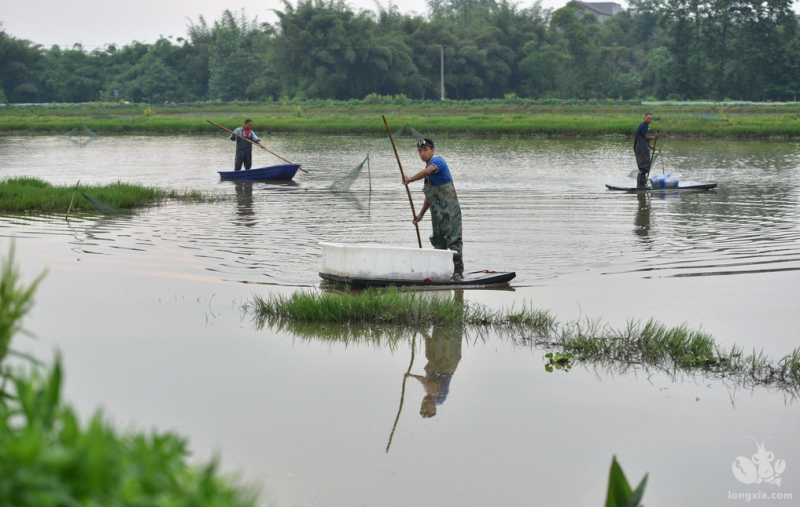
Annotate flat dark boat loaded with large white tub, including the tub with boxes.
[319,243,516,287]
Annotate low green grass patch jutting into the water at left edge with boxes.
[0,177,217,214]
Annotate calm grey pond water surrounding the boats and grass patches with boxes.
[0,135,800,506]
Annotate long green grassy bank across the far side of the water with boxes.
[0,102,800,138]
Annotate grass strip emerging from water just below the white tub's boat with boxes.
[252,289,800,391]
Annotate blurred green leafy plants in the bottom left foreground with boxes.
[0,244,255,507]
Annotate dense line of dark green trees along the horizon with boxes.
[0,0,800,103]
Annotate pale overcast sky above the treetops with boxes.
[0,0,580,50]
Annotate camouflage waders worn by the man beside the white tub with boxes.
[422,178,464,274]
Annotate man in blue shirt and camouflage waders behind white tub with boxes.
[403,139,464,281]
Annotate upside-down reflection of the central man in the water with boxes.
[406,326,462,417]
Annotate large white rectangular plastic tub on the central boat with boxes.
[320,242,455,281]
